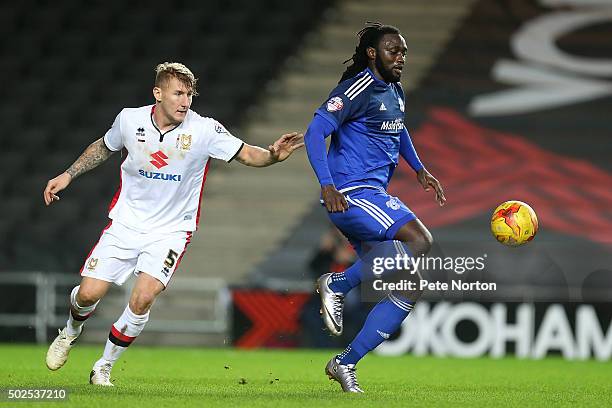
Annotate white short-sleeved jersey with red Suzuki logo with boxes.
[104,105,243,232]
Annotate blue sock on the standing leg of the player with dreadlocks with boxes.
[336,294,414,365]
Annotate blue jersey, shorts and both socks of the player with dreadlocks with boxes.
[304,68,423,367]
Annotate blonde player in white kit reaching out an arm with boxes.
[43,62,303,386]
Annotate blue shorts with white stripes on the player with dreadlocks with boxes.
[328,188,416,255]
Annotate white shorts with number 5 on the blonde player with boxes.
[81,221,193,287]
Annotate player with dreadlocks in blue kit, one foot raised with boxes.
[305,23,446,392]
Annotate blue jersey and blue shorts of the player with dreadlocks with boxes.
[306,69,423,255]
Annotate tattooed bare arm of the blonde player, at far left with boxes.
[43,138,115,205]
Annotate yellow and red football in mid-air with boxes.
[491,200,538,246]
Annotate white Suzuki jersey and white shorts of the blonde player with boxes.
[81,105,244,286]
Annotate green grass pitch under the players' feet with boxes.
[0,344,612,408]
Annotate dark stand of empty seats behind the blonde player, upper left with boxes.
[0,0,330,273]
